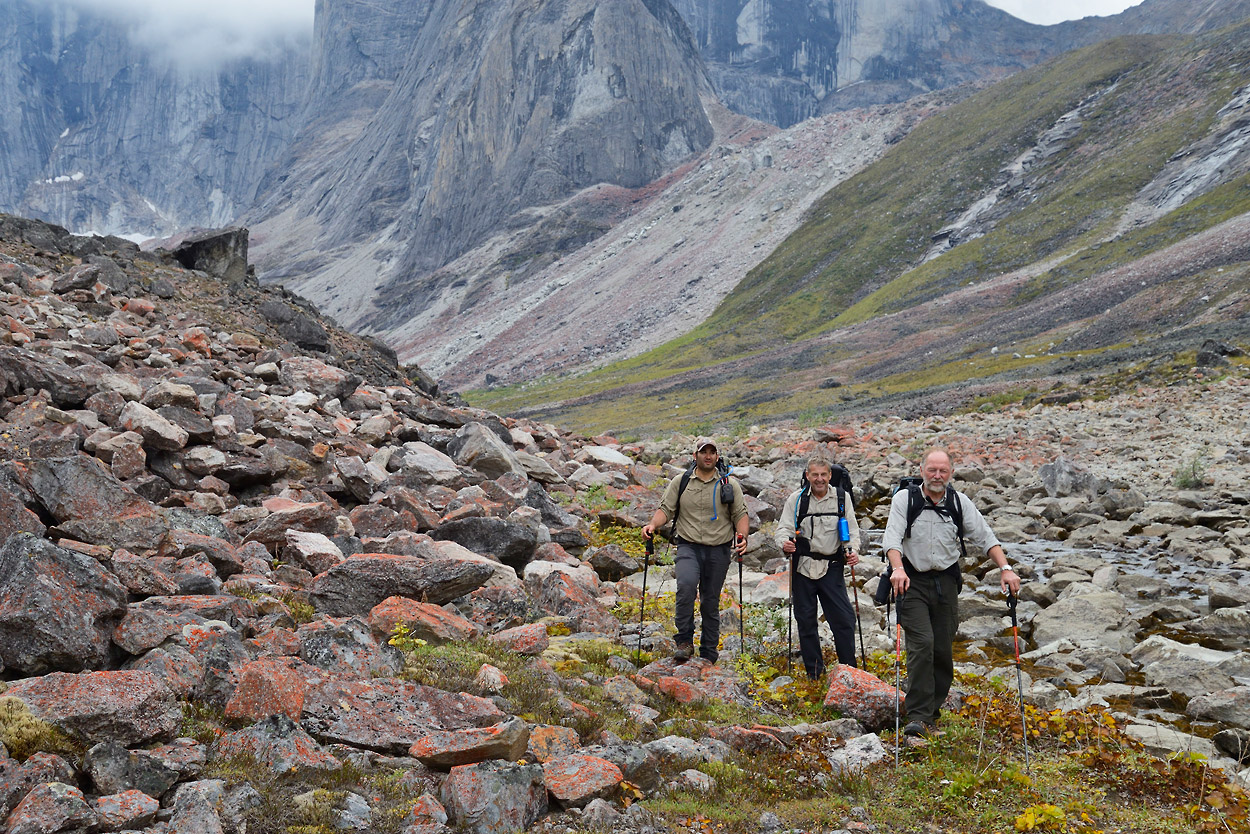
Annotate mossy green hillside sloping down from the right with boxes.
[471,23,1250,431]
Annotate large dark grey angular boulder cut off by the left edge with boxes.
[0,533,126,675]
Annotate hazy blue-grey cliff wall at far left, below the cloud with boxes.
[0,0,309,236]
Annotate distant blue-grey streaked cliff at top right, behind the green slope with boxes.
[673,0,1250,126]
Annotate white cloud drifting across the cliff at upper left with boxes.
[51,0,314,66]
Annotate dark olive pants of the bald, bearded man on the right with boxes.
[899,571,959,724]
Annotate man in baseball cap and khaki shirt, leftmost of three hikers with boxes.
[643,438,749,663]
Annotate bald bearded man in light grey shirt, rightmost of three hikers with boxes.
[881,449,1020,735]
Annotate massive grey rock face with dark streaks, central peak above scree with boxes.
[251,0,713,321]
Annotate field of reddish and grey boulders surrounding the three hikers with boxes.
[0,218,1250,834]
